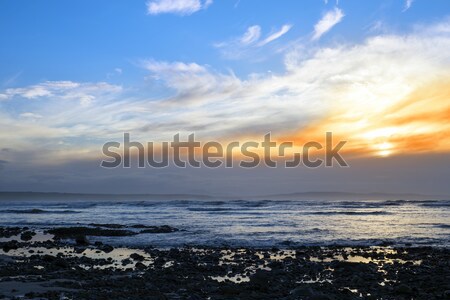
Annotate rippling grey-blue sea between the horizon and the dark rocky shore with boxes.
[0,199,450,247]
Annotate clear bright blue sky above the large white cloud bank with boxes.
[0,0,449,87]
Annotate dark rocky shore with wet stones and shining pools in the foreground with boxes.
[0,224,450,299]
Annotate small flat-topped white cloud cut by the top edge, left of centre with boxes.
[147,0,212,15]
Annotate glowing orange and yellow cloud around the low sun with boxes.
[279,79,450,156]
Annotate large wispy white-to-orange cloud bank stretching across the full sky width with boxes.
[0,18,450,168]
